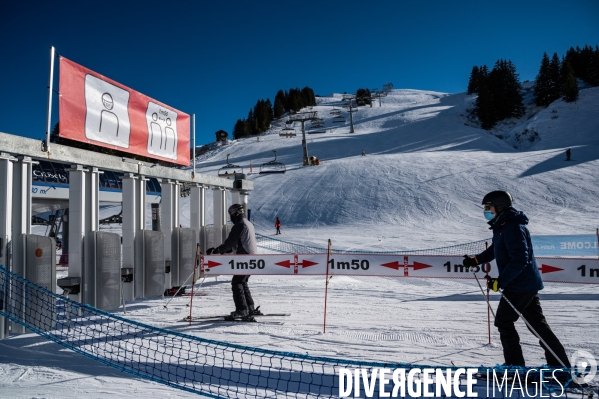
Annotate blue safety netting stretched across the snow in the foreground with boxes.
[0,266,582,398]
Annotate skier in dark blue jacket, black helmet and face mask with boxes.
[463,191,570,367]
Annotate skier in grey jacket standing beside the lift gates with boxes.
[206,204,262,321]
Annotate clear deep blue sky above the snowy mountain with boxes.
[0,0,599,150]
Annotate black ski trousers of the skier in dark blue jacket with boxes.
[495,291,570,367]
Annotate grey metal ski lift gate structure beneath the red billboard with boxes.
[0,132,254,339]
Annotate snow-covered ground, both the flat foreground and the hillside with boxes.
[0,88,599,398]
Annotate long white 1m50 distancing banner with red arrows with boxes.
[200,253,599,284]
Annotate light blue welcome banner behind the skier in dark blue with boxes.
[531,234,599,258]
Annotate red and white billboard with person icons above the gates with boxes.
[59,57,190,166]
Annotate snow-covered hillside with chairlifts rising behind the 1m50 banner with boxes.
[189,88,599,250]
